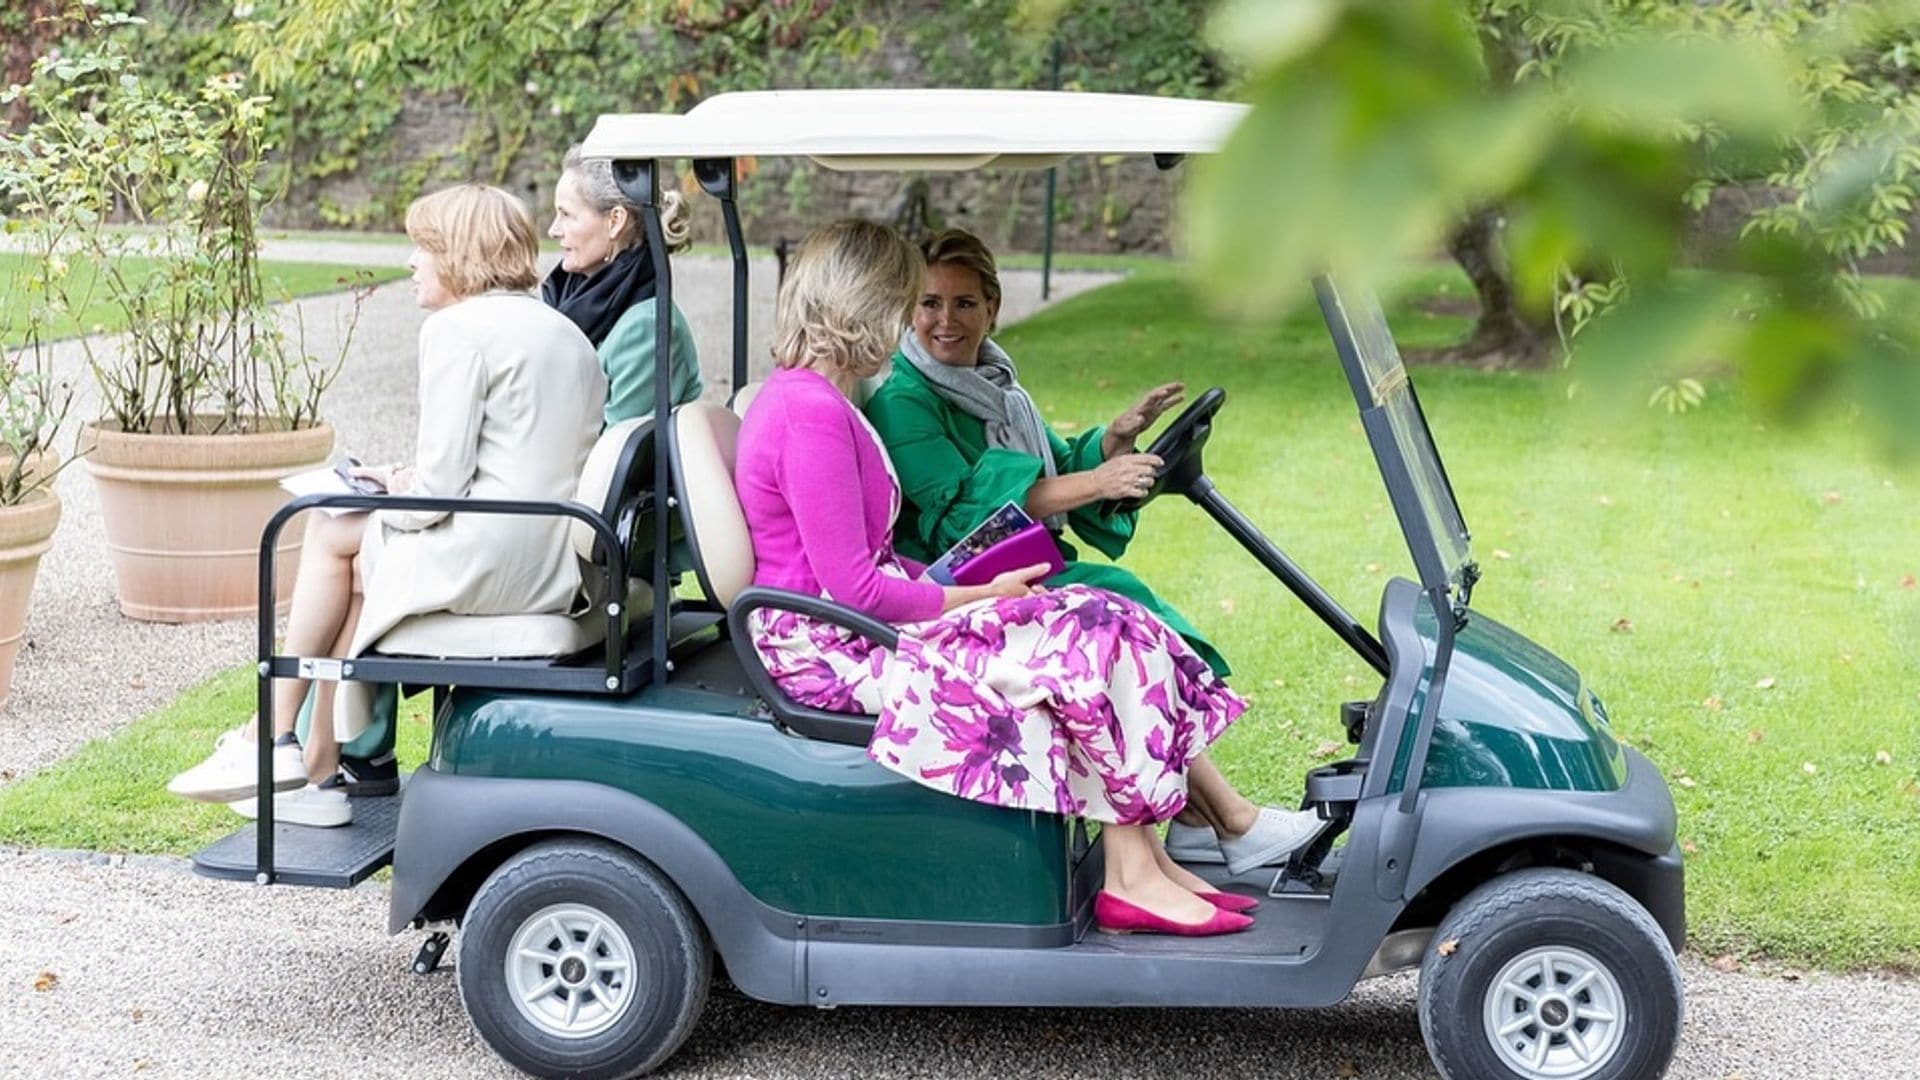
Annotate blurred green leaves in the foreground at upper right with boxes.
[1188,0,1920,457]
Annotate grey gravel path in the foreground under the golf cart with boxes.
[0,851,1920,1080]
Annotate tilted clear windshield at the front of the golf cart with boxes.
[1313,277,1480,605]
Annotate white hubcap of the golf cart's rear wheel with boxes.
[505,903,634,1040]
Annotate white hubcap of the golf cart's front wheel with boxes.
[1484,945,1626,1080]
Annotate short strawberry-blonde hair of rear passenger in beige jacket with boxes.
[407,184,540,300]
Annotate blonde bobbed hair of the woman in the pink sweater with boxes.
[774,219,925,379]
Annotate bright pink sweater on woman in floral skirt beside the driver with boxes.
[733,369,945,625]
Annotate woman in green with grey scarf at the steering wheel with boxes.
[866,229,1229,675]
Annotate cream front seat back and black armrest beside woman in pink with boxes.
[666,399,900,746]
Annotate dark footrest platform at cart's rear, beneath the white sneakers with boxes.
[194,796,401,888]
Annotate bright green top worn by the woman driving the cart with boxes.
[866,354,1139,563]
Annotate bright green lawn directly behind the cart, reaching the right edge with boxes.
[0,259,1920,969]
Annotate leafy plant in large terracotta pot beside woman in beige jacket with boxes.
[0,8,361,623]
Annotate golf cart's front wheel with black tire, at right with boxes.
[1419,869,1684,1080]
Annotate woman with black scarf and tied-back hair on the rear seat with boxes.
[540,146,701,425]
